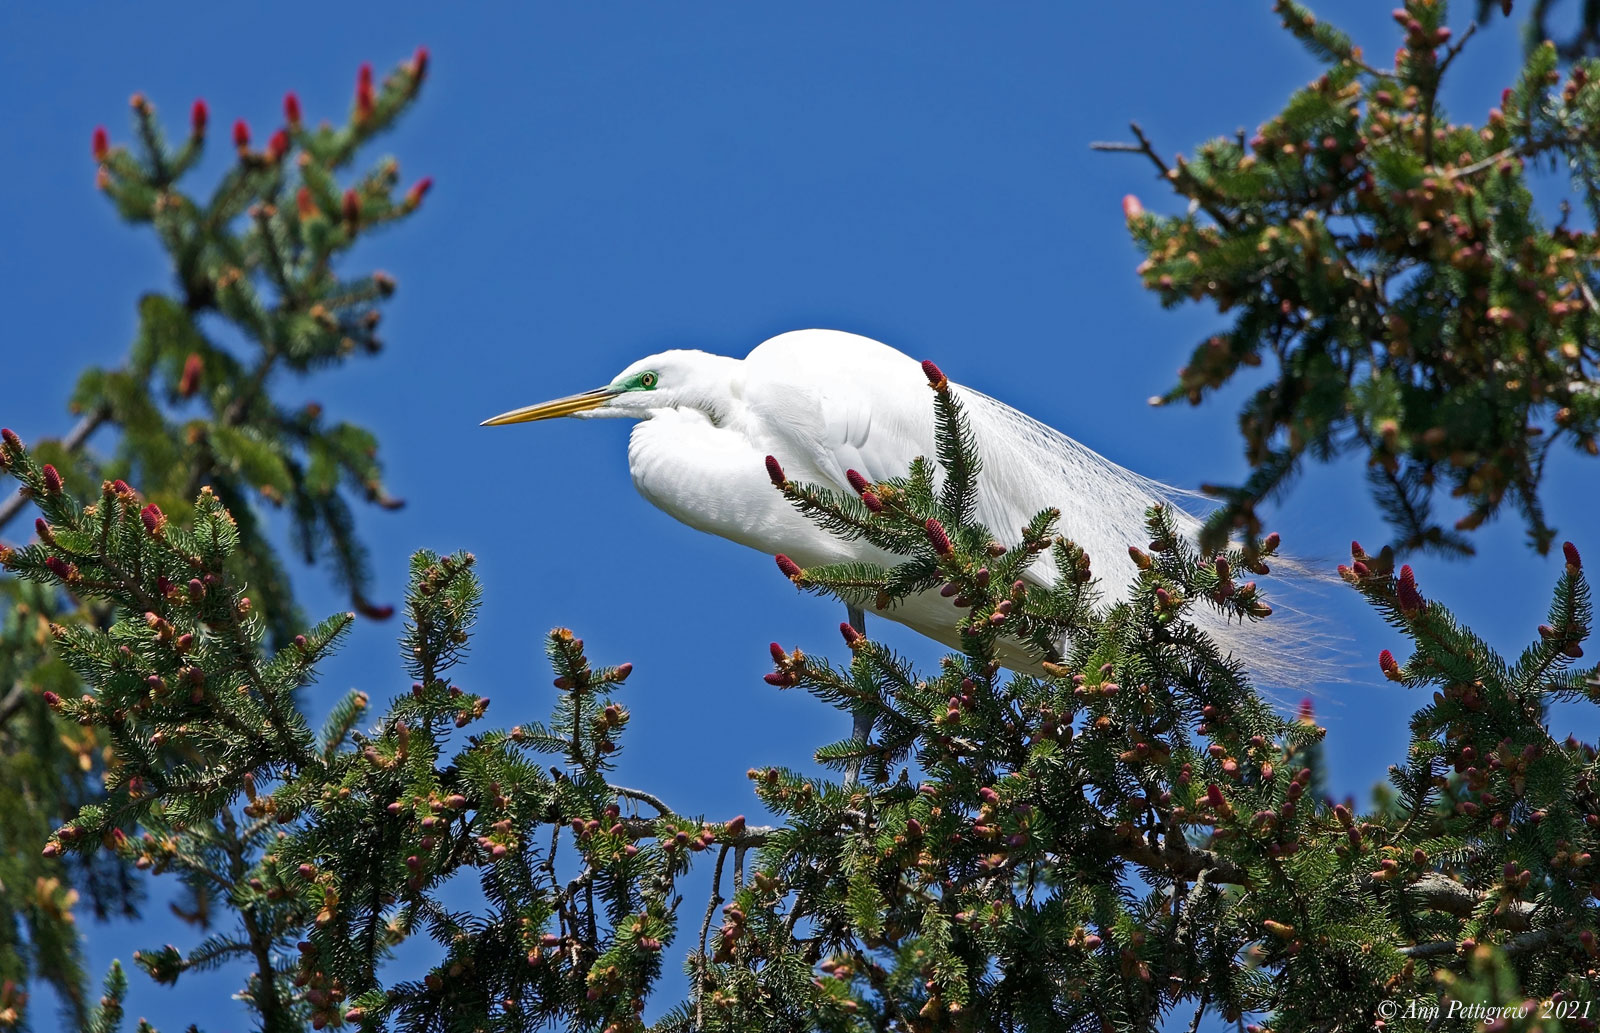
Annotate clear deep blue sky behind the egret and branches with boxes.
[0,2,1600,1033]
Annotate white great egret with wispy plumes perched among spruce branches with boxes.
[483,329,1312,690]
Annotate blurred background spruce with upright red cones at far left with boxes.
[0,50,429,1028]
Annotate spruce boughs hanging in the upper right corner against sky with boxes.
[1104,0,1600,553]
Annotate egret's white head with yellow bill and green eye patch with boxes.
[482,350,738,427]
